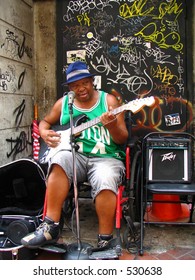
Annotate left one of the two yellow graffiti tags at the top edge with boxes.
[119,0,154,19]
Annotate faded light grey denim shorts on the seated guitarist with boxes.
[48,151,125,199]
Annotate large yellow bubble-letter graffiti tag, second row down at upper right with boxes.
[135,22,183,51]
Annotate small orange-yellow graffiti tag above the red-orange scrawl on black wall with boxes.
[151,65,178,86]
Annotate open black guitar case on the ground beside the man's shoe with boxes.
[0,158,46,259]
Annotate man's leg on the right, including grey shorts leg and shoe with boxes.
[88,158,125,247]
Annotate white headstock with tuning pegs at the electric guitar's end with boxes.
[123,96,155,113]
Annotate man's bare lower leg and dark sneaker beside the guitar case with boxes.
[21,164,69,248]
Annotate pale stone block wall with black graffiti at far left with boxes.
[0,0,34,165]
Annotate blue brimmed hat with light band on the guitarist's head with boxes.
[64,61,95,84]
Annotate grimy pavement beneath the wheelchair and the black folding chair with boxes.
[35,199,195,260]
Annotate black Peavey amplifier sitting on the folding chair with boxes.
[146,138,191,183]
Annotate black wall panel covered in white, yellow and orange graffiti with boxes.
[57,0,192,135]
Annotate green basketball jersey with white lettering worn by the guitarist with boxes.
[60,91,125,160]
